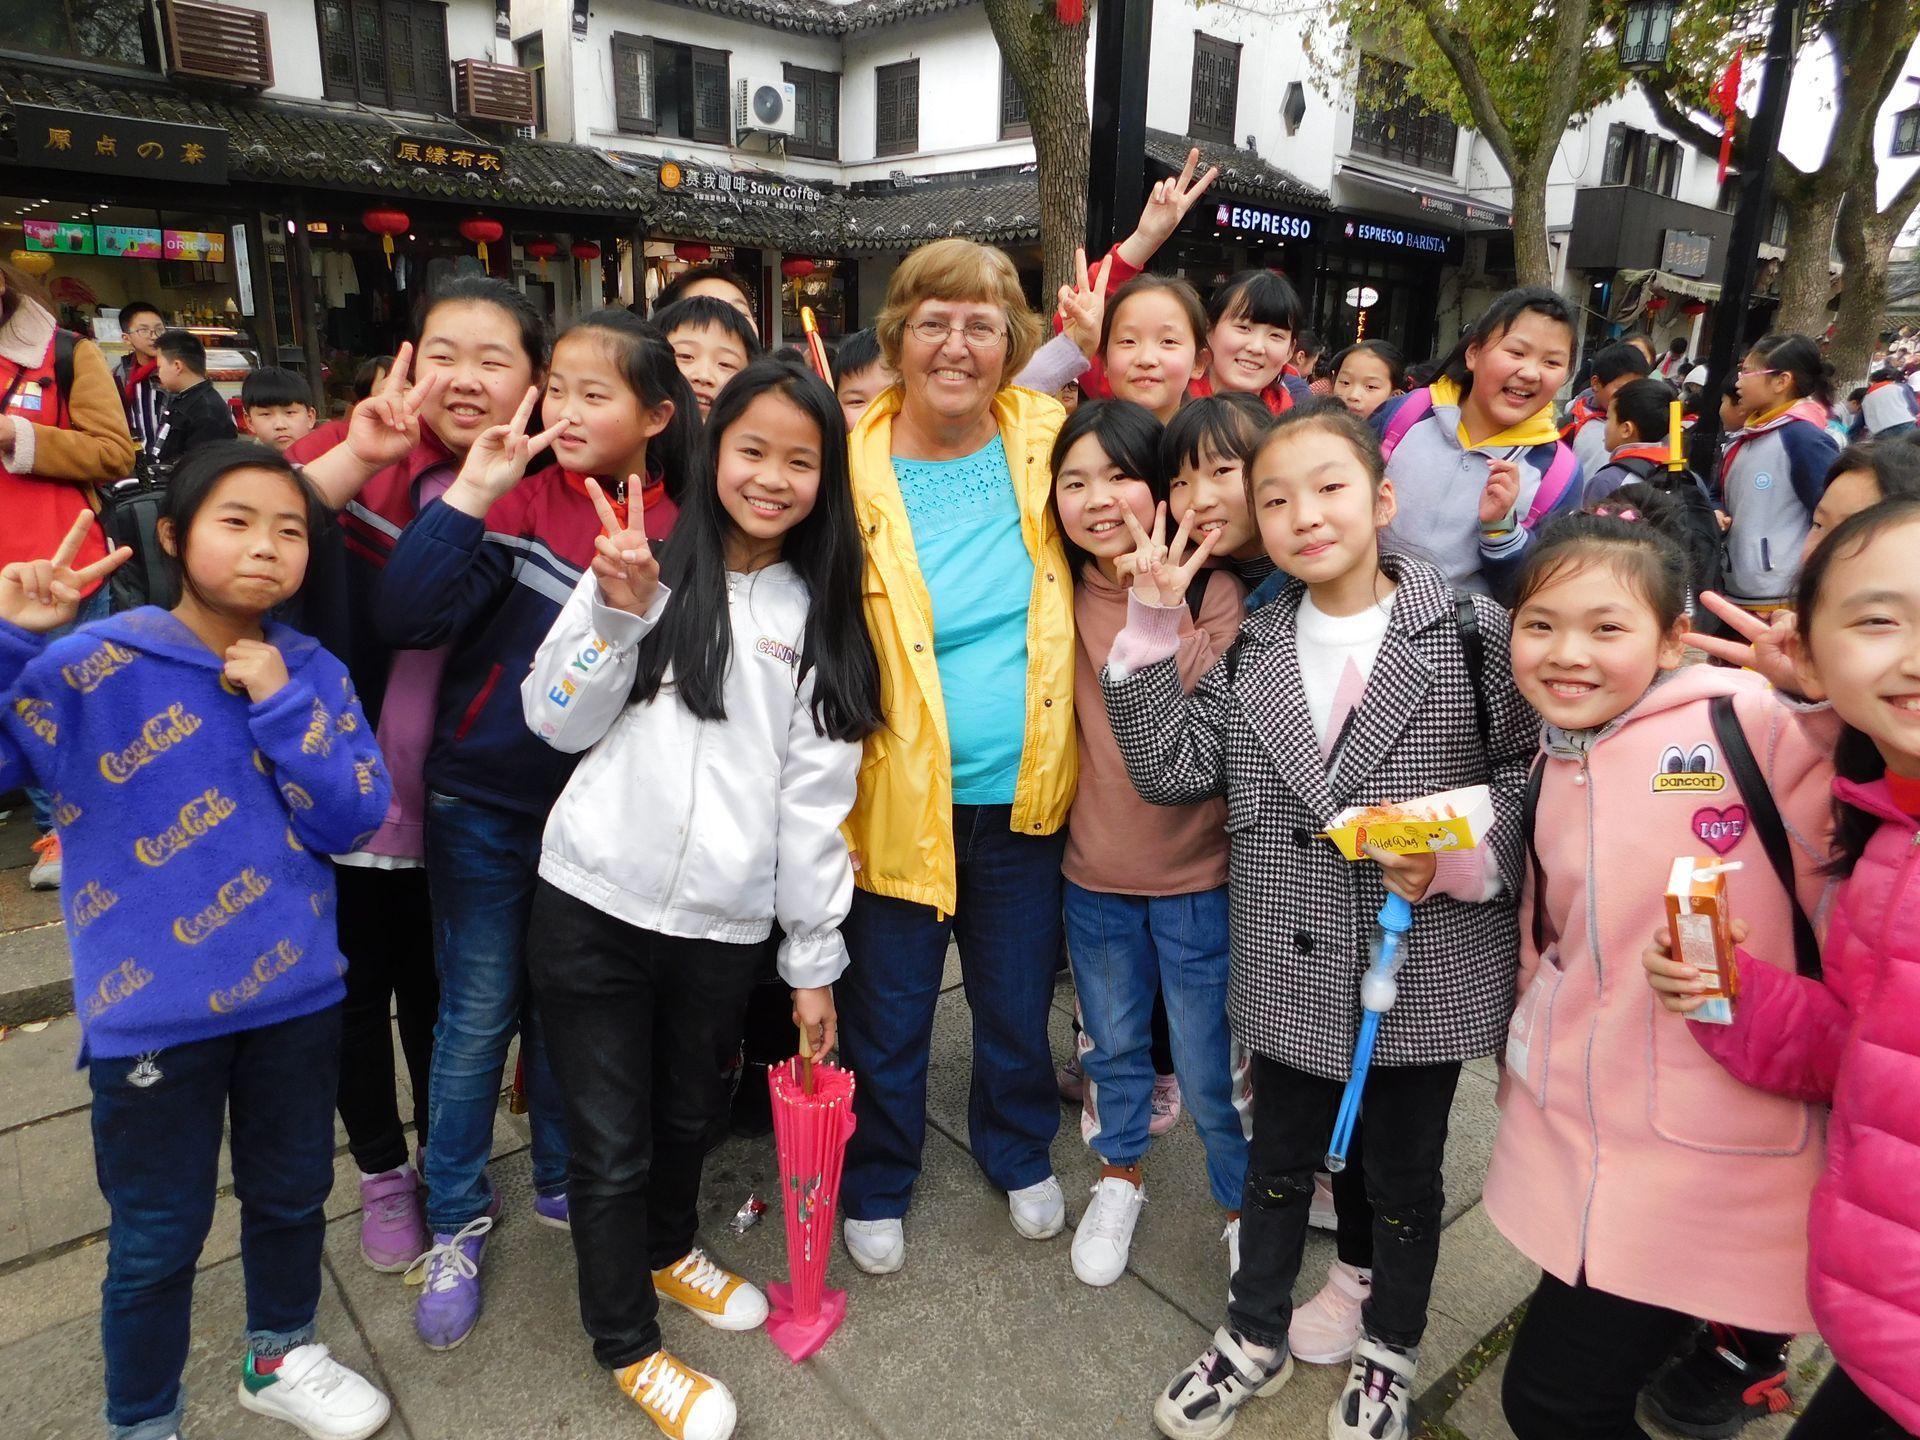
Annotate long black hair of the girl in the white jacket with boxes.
[632,357,881,741]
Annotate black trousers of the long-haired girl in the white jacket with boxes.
[526,881,764,1369]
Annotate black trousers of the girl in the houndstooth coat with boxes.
[1227,1054,1459,1350]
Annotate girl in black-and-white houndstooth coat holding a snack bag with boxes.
[1102,411,1538,1440]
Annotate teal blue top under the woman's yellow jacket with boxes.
[893,436,1033,804]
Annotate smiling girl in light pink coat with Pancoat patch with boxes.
[1486,511,1832,1440]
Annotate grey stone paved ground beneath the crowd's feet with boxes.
[0,816,1827,1440]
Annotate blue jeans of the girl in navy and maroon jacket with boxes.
[426,791,566,1235]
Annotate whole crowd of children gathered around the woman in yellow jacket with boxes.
[0,154,1920,1440]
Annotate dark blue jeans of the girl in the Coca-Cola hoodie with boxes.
[86,1006,340,1440]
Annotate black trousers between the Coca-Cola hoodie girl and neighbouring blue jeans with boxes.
[334,866,440,1175]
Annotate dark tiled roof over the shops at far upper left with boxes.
[0,65,651,215]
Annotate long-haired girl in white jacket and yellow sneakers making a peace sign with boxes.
[520,359,879,1440]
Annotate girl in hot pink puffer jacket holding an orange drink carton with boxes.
[1645,499,1920,1440]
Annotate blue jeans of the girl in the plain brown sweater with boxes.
[1066,881,1246,1210]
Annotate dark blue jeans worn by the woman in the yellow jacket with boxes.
[833,804,1066,1219]
